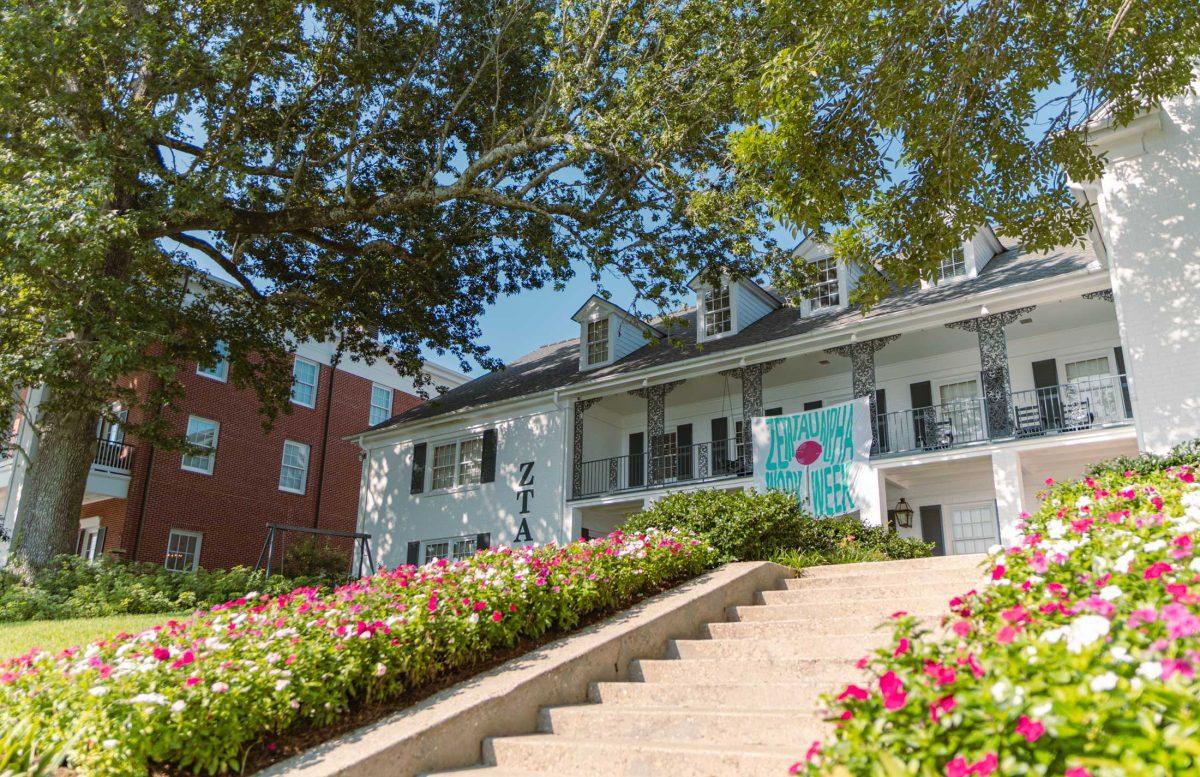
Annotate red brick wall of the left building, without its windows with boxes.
[92,365,420,568]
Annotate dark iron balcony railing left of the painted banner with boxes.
[575,439,750,498]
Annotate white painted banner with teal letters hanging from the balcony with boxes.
[752,397,871,518]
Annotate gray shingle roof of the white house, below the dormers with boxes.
[372,246,1097,429]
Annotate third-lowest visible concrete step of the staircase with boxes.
[588,681,841,715]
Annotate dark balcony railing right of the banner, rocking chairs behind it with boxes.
[874,375,1133,456]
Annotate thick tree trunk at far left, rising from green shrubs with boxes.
[8,398,97,580]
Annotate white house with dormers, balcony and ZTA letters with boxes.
[356,86,1200,565]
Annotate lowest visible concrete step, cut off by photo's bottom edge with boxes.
[484,734,803,777]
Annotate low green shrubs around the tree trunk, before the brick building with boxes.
[0,556,328,622]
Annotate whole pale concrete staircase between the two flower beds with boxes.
[429,555,984,777]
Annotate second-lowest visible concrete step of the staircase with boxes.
[539,704,832,748]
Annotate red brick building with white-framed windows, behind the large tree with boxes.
[0,343,466,571]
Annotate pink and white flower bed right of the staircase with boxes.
[793,466,1200,777]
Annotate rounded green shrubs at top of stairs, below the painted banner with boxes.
[625,490,932,568]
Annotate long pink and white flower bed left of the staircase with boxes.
[0,531,716,775]
